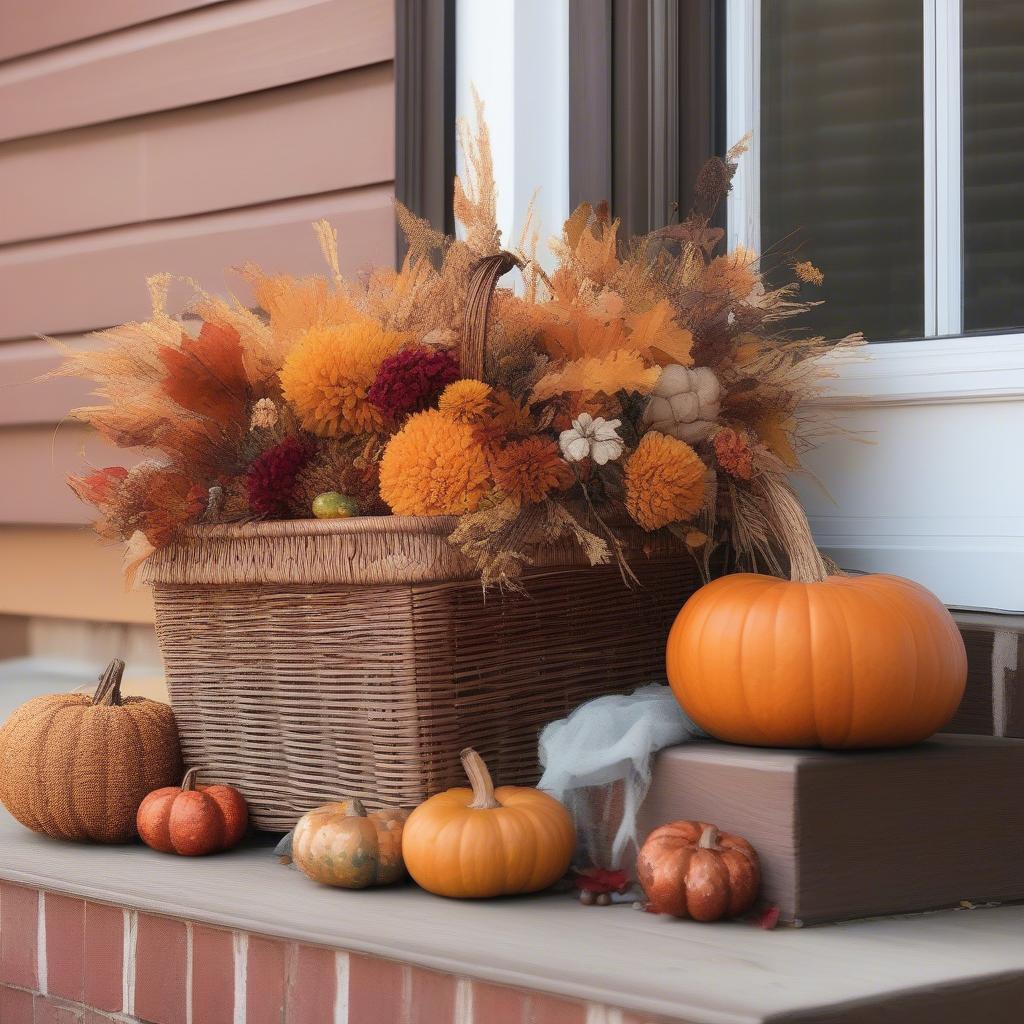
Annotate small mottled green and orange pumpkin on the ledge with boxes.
[292,800,409,889]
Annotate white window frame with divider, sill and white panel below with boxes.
[726,0,1024,612]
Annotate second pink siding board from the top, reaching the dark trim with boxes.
[0,0,394,140]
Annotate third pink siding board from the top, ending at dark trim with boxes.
[0,63,394,243]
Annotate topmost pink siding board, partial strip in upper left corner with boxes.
[0,0,214,60]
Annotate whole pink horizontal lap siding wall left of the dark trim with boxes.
[0,0,394,615]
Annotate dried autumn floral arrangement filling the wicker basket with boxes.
[59,103,861,587]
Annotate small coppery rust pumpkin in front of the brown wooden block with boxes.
[637,821,761,921]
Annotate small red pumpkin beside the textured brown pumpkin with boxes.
[135,768,249,857]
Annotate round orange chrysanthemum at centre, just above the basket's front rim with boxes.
[381,409,492,515]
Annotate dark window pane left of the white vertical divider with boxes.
[761,0,925,341]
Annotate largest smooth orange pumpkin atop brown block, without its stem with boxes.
[666,573,967,749]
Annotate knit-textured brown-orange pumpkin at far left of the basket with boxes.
[0,658,181,843]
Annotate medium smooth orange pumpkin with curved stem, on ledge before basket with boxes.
[401,748,575,899]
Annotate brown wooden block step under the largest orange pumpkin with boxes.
[639,735,1024,924]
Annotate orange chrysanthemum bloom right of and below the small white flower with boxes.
[626,430,705,529]
